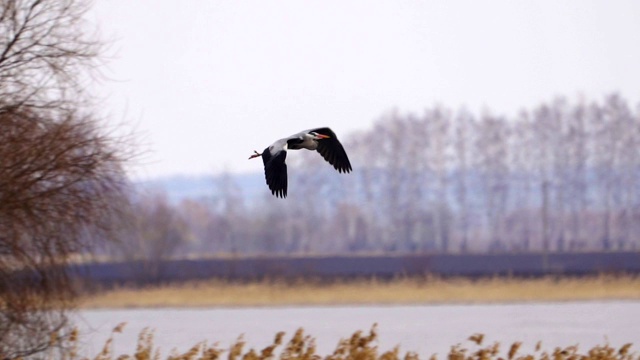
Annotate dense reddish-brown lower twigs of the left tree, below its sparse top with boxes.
[0,112,129,358]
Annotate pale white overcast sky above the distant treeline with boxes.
[89,0,640,179]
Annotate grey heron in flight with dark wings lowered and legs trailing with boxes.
[249,127,351,198]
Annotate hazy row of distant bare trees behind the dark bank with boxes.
[100,94,640,258]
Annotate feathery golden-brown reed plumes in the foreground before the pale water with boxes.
[45,323,640,360]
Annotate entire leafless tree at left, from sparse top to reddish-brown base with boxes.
[0,0,128,359]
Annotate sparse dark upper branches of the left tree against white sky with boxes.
[0,0,101,112]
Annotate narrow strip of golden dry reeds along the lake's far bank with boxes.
[80,275,640,308]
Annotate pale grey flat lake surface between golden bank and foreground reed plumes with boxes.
[77,301,640,359]
